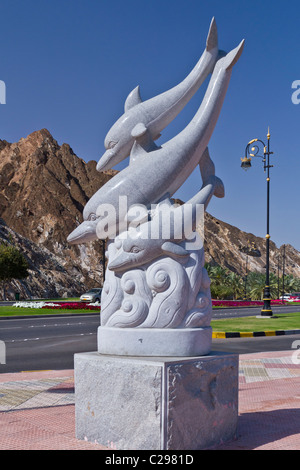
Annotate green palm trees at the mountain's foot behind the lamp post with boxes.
[205,264,300,300]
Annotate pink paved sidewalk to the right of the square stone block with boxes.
[220,351,300,450]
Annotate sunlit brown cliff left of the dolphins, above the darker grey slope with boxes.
[0,129,115,298]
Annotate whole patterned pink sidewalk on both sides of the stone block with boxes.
[0,351,300,450]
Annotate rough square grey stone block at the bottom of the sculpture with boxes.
[75,352,238,450]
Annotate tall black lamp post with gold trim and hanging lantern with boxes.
[241,129,273,317]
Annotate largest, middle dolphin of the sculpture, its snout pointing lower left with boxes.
[67,40,244,244]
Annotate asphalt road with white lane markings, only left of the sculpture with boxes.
[0,314,99,373]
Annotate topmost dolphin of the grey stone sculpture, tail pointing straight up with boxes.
[97,18,219,171]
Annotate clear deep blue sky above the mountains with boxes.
[0,0,300,250]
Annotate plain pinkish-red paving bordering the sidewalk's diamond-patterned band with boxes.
[0,351,300,450]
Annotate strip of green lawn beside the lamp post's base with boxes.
[211,312,300,333]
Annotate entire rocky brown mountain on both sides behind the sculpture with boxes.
[0,129,300,297]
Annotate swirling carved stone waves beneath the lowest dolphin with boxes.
[101,242,212,328]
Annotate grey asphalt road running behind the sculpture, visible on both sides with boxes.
[0,307,300,373]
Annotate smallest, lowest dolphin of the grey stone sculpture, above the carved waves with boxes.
[108,149,224,273]
